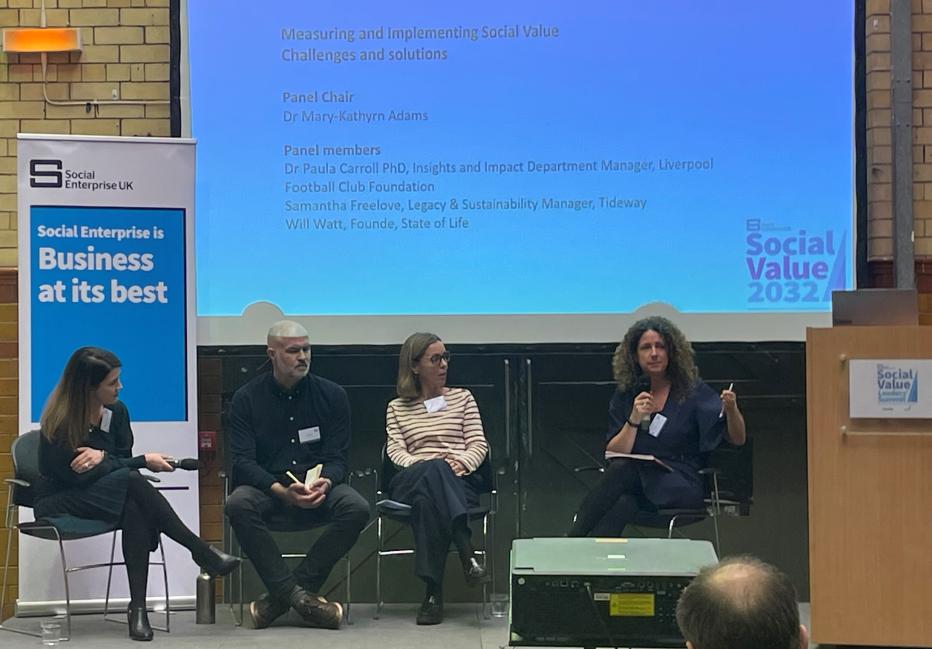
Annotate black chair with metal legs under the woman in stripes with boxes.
[374,445,498,619]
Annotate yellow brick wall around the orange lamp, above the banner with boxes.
[0,0,170,267]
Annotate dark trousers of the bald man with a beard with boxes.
[225,484,369,597]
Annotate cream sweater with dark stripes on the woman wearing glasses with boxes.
[385,388,489,473]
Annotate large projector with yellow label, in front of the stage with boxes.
[509,538,718,647]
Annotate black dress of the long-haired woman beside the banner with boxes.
[34,401,148,536]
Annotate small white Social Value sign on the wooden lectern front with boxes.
[848,358,932,419]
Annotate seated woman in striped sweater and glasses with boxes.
[385,333,490,624]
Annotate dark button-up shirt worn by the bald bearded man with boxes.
[230,372,350,492]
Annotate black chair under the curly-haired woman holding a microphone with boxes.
[573,437,753,555]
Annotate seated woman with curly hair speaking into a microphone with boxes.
[568,316,745,536]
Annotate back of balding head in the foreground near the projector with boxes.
[676,556,809,649]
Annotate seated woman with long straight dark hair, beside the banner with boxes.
[35,347,240,640]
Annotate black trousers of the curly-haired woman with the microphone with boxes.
[567,459,656,537]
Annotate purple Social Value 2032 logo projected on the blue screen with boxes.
[745,219,848,310]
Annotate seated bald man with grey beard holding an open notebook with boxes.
[225,320,369,629]
